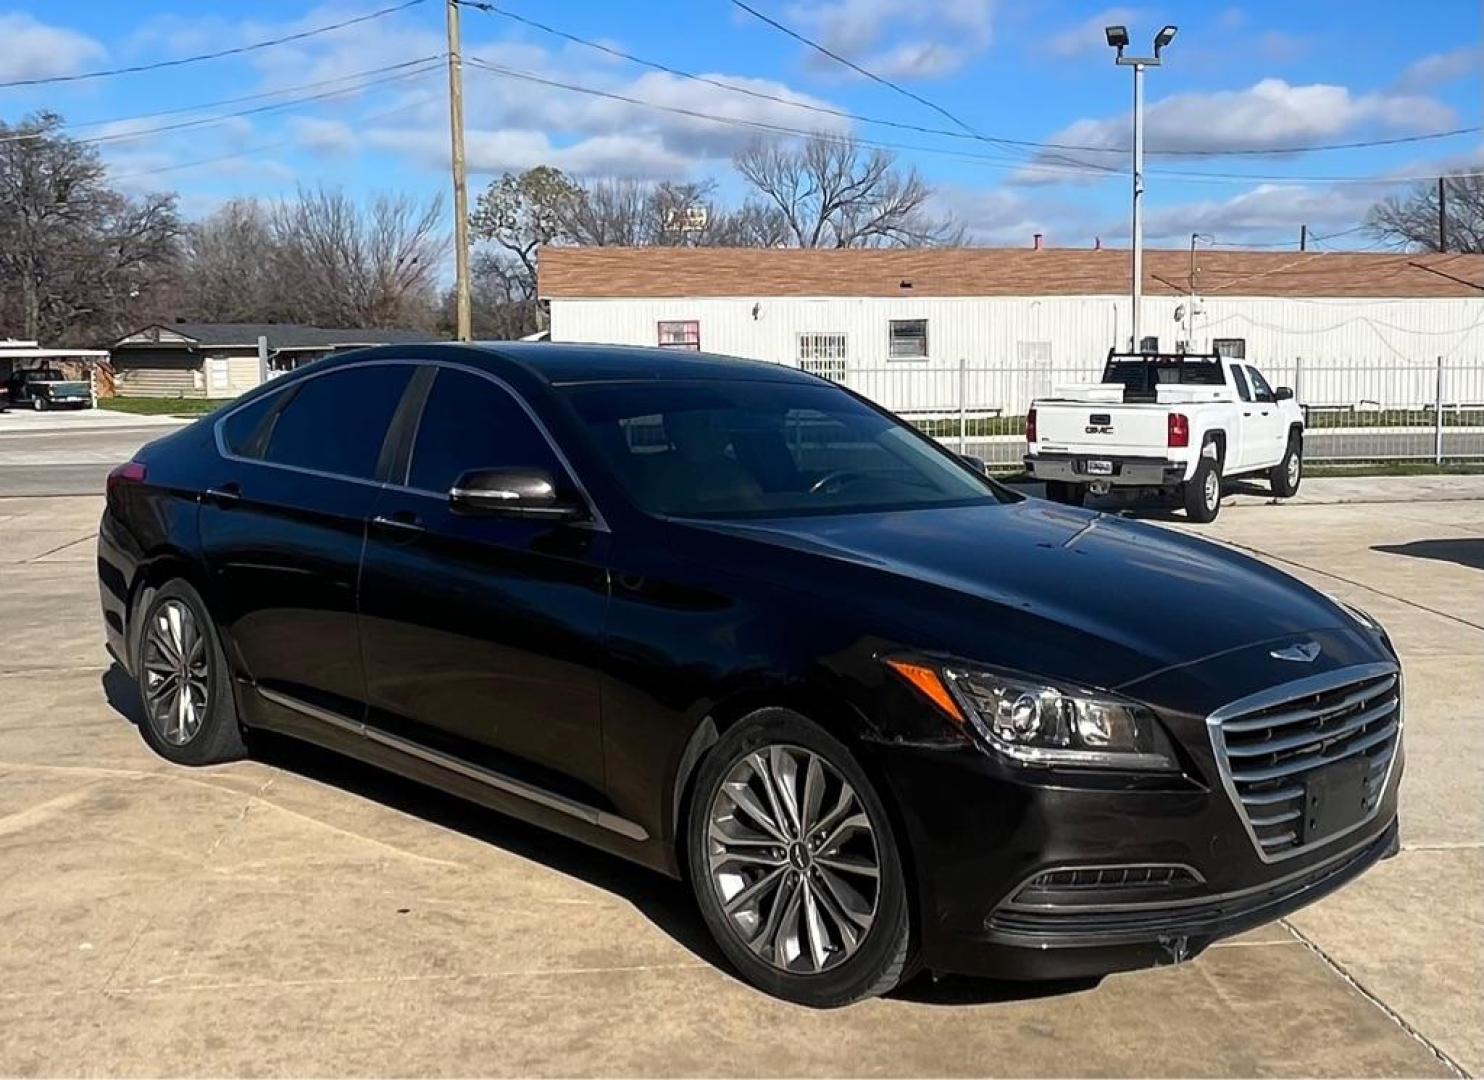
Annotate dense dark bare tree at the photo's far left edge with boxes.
[0,113,181,341]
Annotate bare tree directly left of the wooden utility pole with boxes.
[269,188,447,326]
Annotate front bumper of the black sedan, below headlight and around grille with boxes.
[873,649,1404,979]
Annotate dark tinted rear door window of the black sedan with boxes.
[263,363,413,479]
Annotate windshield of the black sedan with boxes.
[565,380,1005,518]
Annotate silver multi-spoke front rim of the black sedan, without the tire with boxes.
[706,745,881,975]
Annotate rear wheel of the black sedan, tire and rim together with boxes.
[134,579,246,765]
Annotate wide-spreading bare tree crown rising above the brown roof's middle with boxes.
[733,135,963,248]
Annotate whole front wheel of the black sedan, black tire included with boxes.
[686,709,914,1009]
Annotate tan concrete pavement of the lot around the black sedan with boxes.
[0,486,1484,1076]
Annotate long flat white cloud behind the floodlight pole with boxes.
[1017,79,1454,184]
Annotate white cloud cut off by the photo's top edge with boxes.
[788,0,996,79]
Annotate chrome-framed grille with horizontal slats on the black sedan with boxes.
[1211,666,1402,859]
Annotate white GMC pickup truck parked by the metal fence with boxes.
[1025,352,1303,522]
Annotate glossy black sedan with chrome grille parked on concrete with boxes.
[98,344,1402,1006]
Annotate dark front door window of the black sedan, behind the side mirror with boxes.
[407,368,564,494]
